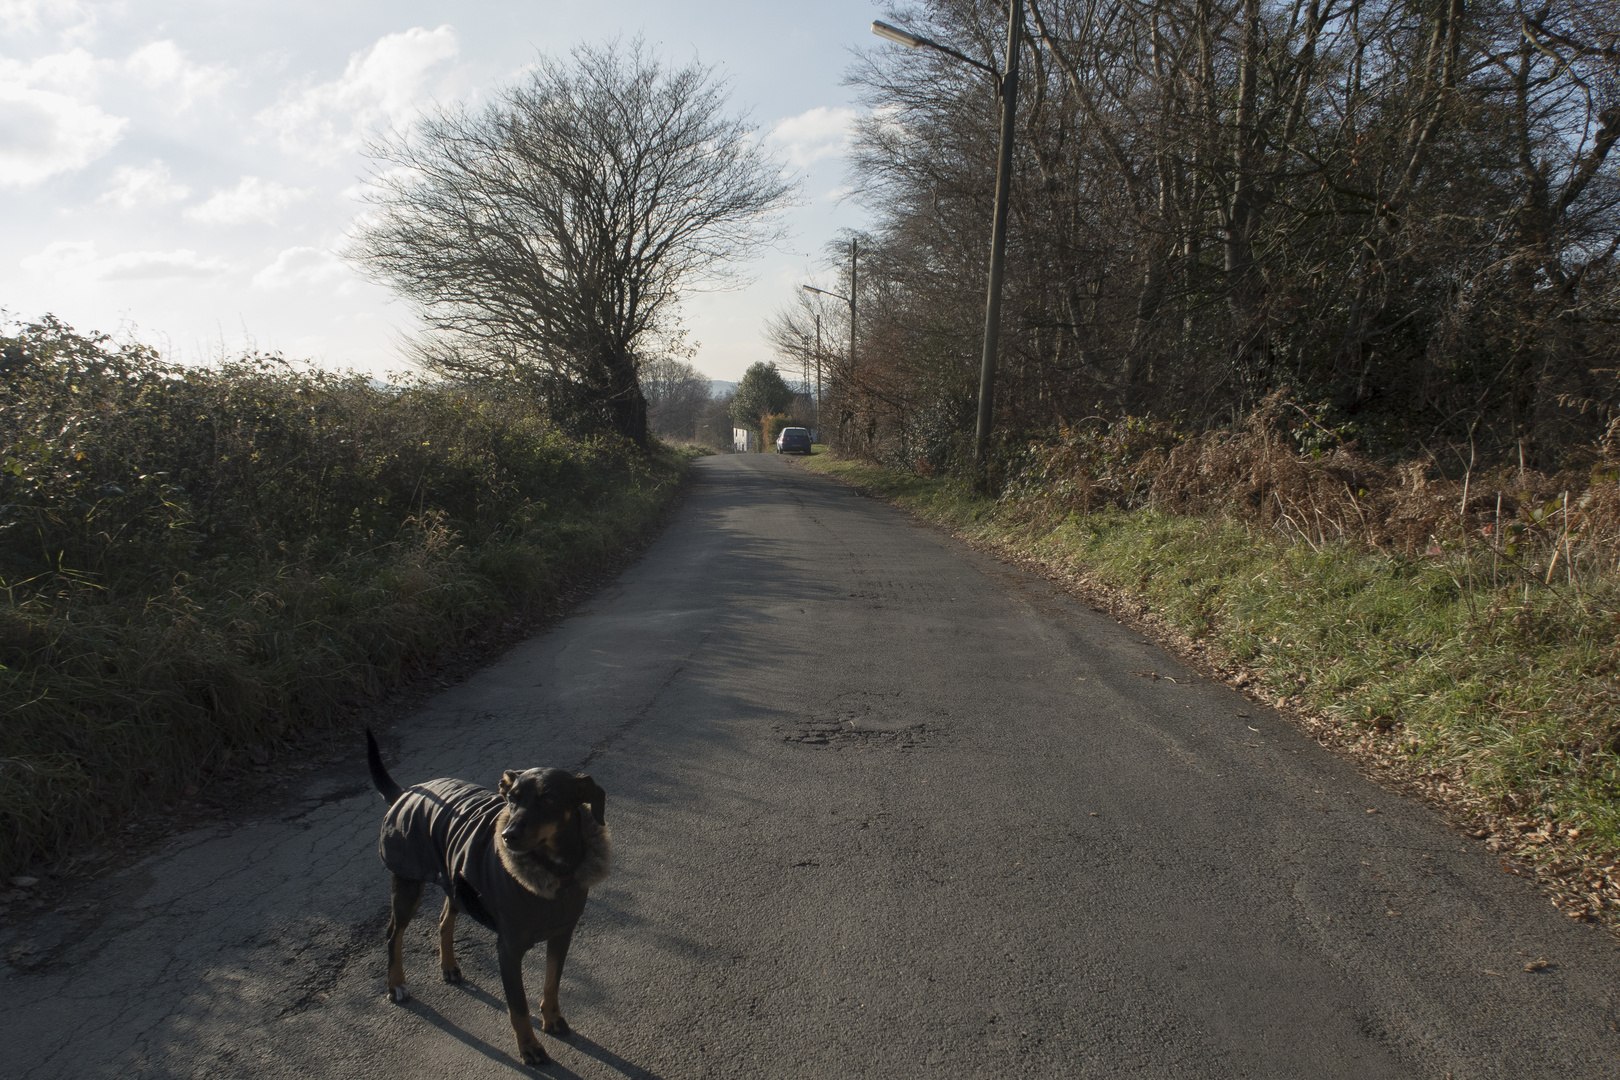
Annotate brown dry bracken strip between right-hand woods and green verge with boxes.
[1003,393,1620,604]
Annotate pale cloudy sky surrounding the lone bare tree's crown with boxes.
[0,0,883,381]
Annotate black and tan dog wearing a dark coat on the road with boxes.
[366,732,612,1065]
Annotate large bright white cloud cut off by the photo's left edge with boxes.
[0,50,130,188]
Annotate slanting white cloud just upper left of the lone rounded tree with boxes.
[258,26,458,160]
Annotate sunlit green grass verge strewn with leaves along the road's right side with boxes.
[805,455,1620,926]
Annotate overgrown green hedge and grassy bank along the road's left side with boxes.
[0,322,693,876]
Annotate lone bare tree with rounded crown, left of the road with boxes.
[348,40,792,444]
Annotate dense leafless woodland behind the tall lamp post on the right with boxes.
[835,0,1620,466]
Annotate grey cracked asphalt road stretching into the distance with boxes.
[0,457,1620,1080]
